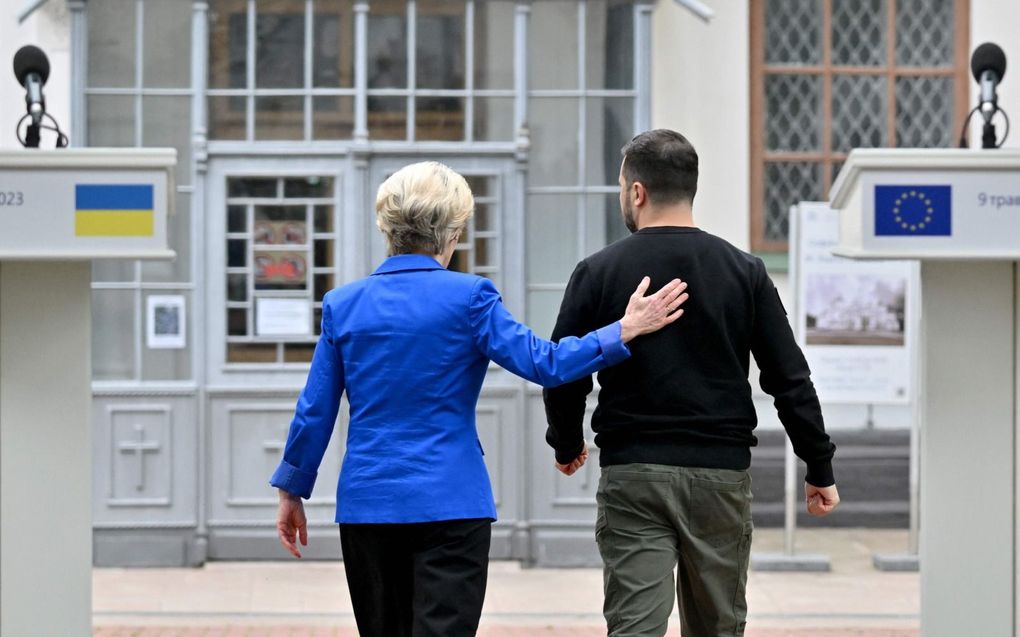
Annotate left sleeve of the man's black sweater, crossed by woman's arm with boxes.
[543,261,597,465]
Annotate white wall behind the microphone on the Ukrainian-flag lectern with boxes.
[0,0,70,148]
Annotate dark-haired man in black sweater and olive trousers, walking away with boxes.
[545,129,839,637]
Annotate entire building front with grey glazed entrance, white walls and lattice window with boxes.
[0,0,1020,565]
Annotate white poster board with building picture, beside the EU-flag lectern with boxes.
[791,202,920,405]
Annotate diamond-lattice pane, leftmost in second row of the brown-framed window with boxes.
[765,75,822,151]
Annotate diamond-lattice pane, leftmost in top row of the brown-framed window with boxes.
[765,0,822,64]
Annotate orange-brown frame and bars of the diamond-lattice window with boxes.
[749,0,970,254]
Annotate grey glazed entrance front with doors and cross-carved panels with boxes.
[77,0,653,564]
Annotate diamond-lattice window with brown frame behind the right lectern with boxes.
[751,0,969,252]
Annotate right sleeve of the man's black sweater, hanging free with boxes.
[751,260,835,487]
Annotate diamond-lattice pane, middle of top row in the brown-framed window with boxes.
[832,0,886,66]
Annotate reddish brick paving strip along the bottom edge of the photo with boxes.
[92,626,921,637]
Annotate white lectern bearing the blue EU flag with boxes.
[831,150,1020,637]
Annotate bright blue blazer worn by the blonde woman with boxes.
[270,255,630,524]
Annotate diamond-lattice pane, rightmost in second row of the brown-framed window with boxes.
[896,77,954,148]
